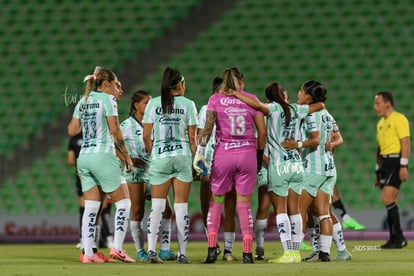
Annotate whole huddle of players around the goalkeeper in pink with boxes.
[68,67,364,263]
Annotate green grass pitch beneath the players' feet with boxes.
[0,240,414,276]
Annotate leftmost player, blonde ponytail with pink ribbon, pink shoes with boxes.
[68,67,135,263]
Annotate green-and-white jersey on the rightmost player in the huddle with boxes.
[302,109,335,176]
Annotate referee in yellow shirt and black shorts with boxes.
[374,92,410,248]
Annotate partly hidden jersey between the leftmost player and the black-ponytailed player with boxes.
[121,115,149,164]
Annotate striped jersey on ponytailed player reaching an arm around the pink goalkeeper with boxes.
[266,102,309,165]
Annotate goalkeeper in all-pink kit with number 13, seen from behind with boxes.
[193,68,266,263]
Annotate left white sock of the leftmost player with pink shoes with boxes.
[82,200,101,257]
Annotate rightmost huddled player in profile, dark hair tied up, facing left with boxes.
[282,80,336,262]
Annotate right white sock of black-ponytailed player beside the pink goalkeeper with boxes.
[174,202,190,255]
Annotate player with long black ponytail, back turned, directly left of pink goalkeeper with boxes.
[143,67,198,263]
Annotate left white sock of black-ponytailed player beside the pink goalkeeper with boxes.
[147,198,167,252]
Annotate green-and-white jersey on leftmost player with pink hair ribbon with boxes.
[73,91,118,154]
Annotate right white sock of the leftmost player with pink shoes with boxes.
[114,198,131,250]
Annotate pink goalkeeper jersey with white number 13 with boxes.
[207,91,259,156]
